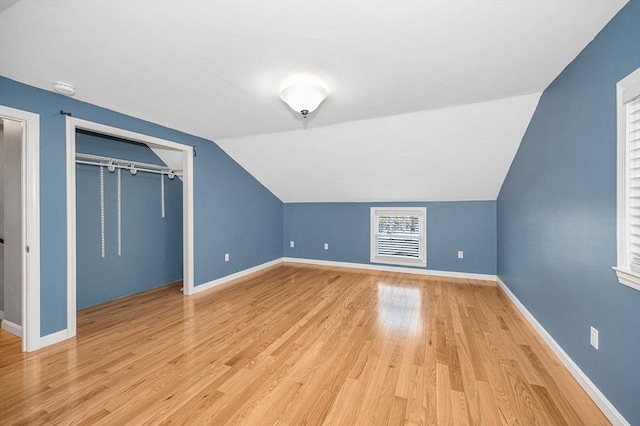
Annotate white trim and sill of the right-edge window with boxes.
[613,68,640,291]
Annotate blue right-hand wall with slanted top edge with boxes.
[498,0,640,425]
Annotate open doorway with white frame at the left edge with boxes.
[0,106,40,352]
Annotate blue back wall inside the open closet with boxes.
[76,132,183,309]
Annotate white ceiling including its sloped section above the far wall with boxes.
[0,0,626,201]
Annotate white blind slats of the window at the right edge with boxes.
[625,96,640,272]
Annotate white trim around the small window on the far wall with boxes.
[369,207,427,267]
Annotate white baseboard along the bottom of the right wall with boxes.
[496,277,630,426]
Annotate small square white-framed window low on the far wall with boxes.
[371,207,427,266]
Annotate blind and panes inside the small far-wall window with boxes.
[376,215,420,258]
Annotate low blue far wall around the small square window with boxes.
[283,201,496,275]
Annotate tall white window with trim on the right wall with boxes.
[614,68,640,290]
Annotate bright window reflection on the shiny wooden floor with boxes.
[378,283,422,335]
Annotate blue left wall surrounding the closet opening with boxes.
[0,77,282,336]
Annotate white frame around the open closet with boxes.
[66,117,194,338]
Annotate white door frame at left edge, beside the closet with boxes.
[0,105,40,352]
